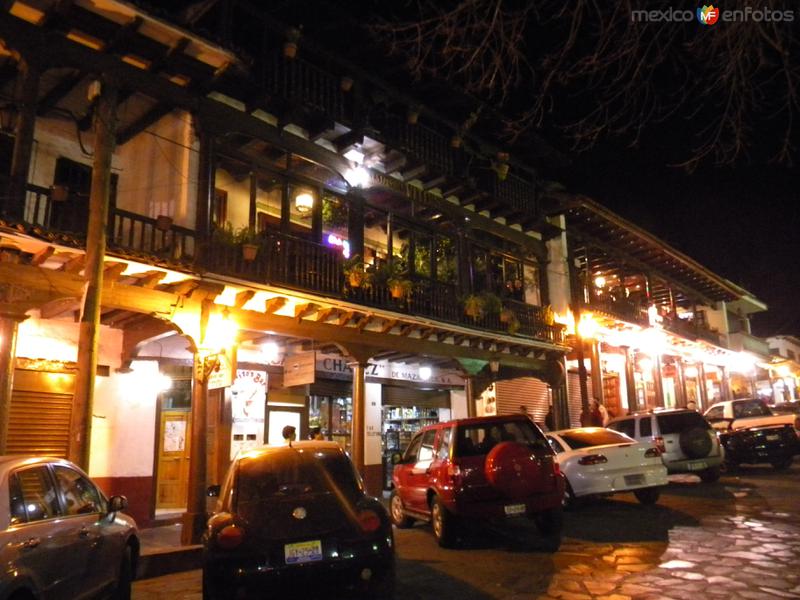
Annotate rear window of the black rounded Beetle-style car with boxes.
[236,448,361,504]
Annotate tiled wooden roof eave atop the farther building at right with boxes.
[560,197,752,306]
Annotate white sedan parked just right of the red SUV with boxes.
[547,427,667,504]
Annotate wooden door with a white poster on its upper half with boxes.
[156,410,191,508]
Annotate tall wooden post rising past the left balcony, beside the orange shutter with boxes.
[69,78,117,471]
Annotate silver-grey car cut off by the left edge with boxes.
[0,456,139,600]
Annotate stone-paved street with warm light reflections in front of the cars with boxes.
[133,459,800,600]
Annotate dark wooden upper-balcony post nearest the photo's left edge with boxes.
[5,58,41,220]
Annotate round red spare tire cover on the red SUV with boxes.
[485,442,545,499]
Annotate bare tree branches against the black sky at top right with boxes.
[370,0,800,169]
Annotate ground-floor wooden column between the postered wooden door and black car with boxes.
[181,344,213,545]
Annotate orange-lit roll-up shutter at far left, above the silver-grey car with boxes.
[6,369,75,458]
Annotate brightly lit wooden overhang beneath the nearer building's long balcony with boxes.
[0,231,569,373]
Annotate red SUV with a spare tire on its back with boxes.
[391,415,565,551]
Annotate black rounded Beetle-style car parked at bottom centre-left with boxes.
[203,441,394,600]
